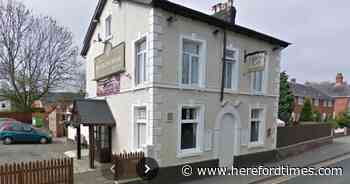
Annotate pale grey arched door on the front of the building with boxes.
[219,114,235,168]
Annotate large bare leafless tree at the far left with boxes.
[0,0,79,111]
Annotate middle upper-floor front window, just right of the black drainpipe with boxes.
[225,49,239,89]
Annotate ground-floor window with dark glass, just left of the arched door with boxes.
[179,106,203,154]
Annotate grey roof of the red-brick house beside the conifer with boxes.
[289,82,332,100]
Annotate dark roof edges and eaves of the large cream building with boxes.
[81,0,290,56]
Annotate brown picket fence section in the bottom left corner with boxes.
[0,158,73,184]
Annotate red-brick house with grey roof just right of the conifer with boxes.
[289,79,335,121]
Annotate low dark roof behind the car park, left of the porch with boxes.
[41,92,84,104]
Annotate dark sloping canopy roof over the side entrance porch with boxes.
[73,99,116,126]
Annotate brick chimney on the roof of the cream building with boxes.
[212,0,237,24]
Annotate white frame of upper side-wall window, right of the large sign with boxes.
[133,35,149,87]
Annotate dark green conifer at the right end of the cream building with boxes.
[278,71,294,122]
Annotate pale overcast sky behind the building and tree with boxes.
[20,0,350,82]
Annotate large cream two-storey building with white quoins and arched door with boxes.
[81,0,289,171]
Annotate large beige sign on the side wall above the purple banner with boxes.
[95,43,125,80]
